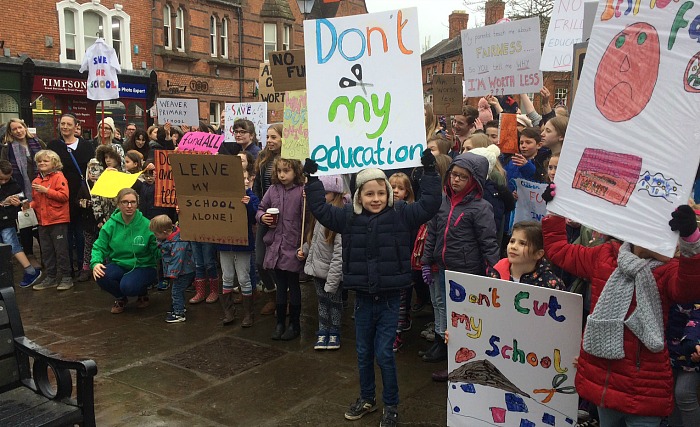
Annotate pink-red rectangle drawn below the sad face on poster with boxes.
[572,148,642,206]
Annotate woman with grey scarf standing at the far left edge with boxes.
[0,119,46,258]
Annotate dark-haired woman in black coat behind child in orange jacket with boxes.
[47,113,95,276]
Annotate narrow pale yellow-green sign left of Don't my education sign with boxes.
[282,90,309,161]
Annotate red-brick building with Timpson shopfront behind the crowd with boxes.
[0,0,367,140]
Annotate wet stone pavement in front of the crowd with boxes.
[10,264,447,427]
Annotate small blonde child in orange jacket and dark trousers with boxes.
[24,150,73,291]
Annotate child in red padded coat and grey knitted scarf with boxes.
[542,189,700,427]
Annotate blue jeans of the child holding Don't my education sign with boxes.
[355,291,400,406]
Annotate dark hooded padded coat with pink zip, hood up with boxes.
[421,153,499,275]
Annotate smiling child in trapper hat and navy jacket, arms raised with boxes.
[304,150,440,425]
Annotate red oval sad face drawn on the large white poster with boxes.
[593,22,660,122]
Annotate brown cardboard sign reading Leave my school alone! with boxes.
[170,153,248,245]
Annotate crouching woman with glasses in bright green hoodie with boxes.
[90,188,158,314]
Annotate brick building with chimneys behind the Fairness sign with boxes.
[421,0,571,113]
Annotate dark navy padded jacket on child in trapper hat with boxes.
[306,172,441,294]
